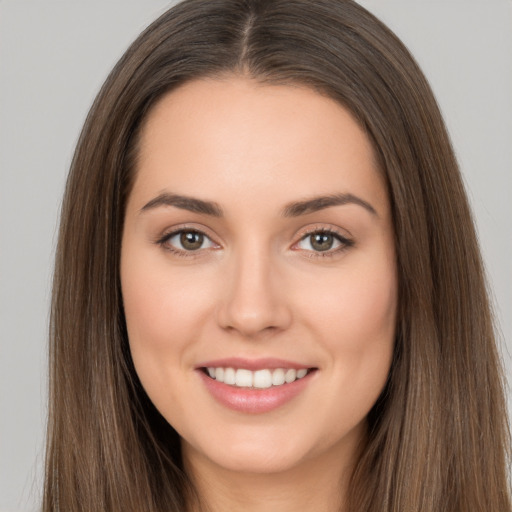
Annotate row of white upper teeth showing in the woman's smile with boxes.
[207,367,308,389]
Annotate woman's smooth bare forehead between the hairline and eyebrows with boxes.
[134,77,387,217]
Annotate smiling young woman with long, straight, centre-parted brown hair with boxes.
[44,0,510,511]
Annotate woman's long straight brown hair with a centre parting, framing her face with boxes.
[43,0,511,512]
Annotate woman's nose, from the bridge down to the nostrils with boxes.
[217,248,292,338]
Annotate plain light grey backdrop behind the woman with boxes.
[0,0,512,512]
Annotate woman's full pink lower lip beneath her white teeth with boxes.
[198,370,316,414]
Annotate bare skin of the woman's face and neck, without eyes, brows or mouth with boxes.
[121,76,397,512]
